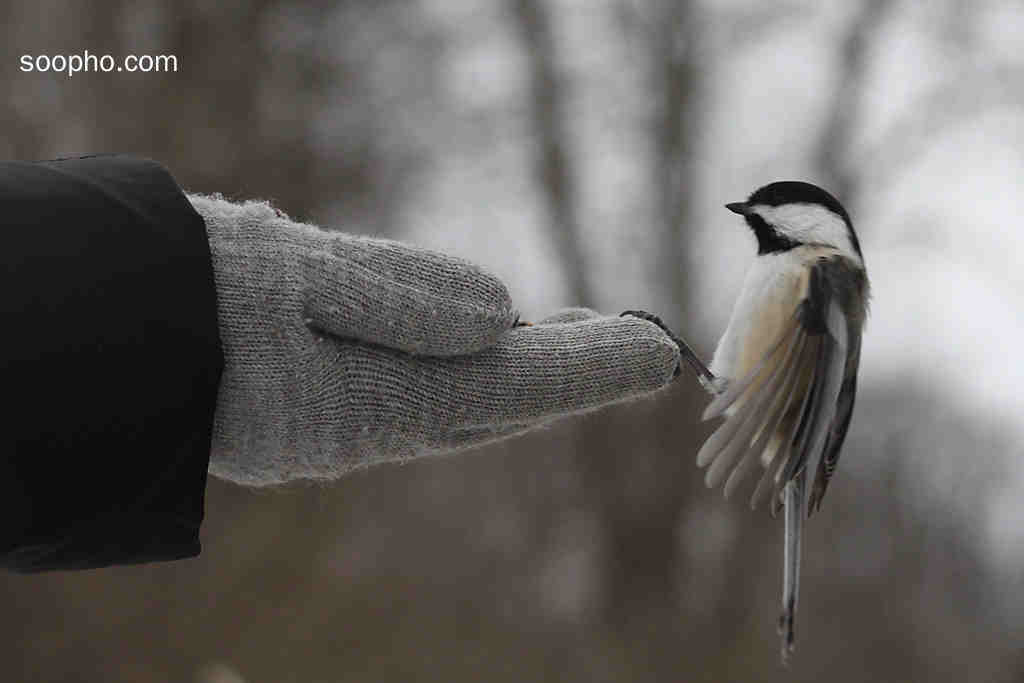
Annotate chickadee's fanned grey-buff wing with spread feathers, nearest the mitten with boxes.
[697,253,859,514]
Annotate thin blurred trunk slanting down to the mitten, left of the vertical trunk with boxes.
[511,0,595,305]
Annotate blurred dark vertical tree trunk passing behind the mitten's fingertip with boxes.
[581,0,700,643]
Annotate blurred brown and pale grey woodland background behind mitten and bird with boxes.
[0,0,1024,683]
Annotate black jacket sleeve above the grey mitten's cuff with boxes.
[0,156,223,571]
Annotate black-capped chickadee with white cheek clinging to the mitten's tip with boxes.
[684,181,868,660]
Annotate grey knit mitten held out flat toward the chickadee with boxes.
[189,195,679,484]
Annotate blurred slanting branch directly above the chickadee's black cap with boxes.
[814,0,893,204]
